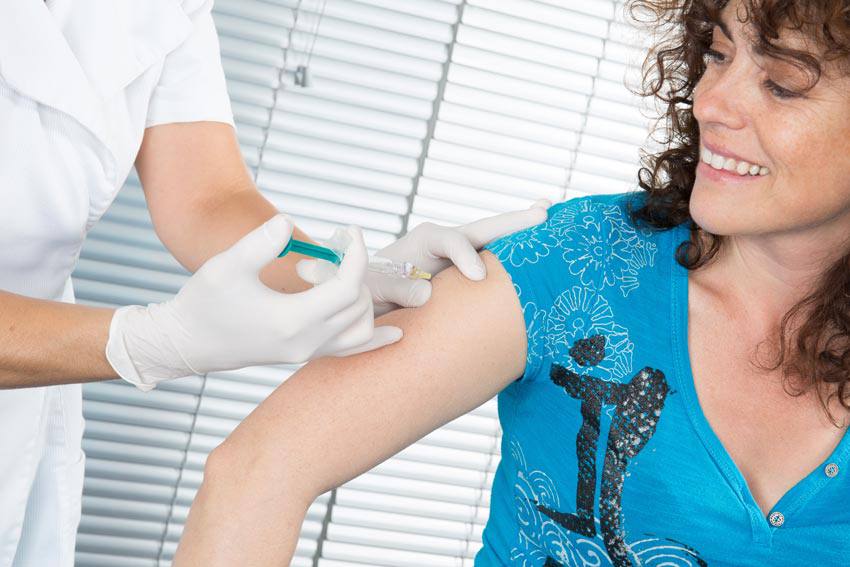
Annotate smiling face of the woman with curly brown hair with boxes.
[690,1,850,246]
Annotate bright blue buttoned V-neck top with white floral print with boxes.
[475,193,850,567]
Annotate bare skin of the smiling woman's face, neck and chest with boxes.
[688,3,850,514]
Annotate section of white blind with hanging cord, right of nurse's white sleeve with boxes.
[215,0,457,248]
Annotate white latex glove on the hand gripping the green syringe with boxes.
[106,215,401,391]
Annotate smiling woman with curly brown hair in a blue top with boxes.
[174,0,850,567]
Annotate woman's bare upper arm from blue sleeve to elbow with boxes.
[218,253,526,497]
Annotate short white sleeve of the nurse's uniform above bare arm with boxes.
[145,1,233,127]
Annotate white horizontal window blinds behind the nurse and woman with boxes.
[74,0,648,567]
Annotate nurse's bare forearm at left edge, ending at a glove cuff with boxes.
[0,291,117,388]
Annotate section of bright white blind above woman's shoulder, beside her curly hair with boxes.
[410,0,648,231]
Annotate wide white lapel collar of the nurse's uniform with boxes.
[0,0,192,149]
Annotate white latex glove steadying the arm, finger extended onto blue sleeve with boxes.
[366,199,552,315]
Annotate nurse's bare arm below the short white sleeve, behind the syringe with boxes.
[136,122,310,292]
